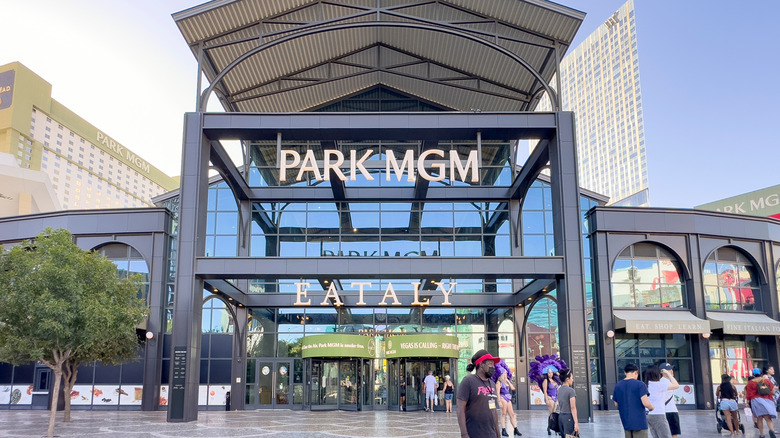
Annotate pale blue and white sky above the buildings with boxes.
[0,0,780,208]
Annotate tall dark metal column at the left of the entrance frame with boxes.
[168,113,209,422]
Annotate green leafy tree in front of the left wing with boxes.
[0,228,147,437]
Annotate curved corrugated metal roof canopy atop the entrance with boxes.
[173,0,585,112]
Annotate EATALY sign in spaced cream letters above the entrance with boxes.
[294,281,458,306]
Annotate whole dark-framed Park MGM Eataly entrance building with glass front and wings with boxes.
[0,0,780,422]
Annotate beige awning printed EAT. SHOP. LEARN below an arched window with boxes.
[612,309,710,334]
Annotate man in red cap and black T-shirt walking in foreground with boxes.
[458,350,501,438]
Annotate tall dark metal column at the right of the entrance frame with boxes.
[549,112,591,422]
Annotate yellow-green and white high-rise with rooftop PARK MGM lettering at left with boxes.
[0,62,178,214]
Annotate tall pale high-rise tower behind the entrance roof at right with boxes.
[537,0,649,206]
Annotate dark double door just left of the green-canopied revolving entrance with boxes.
[246,359,292,409]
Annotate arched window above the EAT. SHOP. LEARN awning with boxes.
[611,242,686,308]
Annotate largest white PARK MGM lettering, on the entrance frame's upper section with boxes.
[279,149,479,183]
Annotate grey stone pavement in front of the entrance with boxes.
[0,410,758,438]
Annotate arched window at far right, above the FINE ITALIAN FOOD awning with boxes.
[702,247,761,310]
